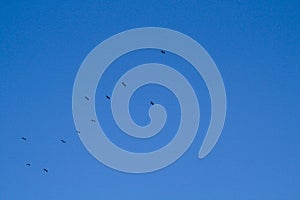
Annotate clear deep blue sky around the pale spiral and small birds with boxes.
[0,1,300,200]
